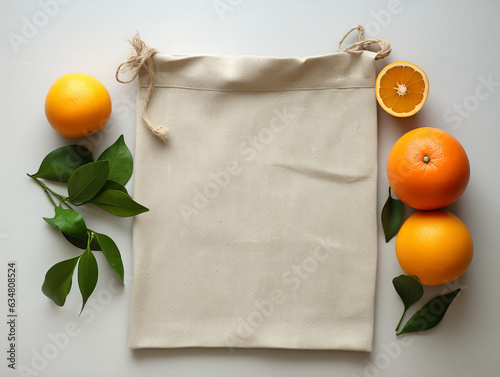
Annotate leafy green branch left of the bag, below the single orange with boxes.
[28,135,148,311]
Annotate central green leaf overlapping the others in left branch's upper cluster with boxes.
[68,161,109,203]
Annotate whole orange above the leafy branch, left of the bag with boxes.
[45,73,111,138]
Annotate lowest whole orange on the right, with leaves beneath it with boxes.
[396,210,473,285]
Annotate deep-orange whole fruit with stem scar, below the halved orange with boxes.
[387,127,470,210]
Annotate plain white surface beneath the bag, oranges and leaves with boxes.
[0,0,500,377]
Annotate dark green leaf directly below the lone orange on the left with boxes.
[33,145,94,182]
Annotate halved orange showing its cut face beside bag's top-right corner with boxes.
[375,62,429,117]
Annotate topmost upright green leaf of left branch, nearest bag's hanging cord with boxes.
[97,135,133,185]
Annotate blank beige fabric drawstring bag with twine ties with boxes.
[117,26,390,351]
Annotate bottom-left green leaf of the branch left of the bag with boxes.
[42,257,80,306]
